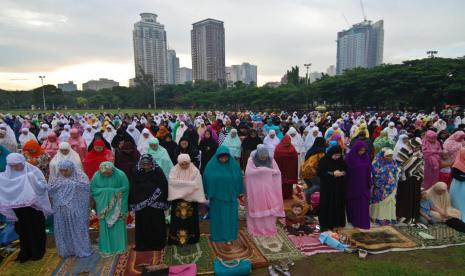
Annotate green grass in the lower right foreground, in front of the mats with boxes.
[253,246,465,276]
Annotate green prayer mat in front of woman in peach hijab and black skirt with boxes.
[163,234,215,275]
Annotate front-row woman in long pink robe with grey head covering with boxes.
[245,147,285,237]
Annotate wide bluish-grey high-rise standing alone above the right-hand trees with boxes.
[336,20,384,75]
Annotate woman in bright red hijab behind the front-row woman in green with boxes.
[82,139,114,179]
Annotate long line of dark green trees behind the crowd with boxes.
[0,57,465,110]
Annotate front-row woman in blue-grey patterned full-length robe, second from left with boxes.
[48,160,92,258]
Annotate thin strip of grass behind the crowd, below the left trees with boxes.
[0,108,204,114]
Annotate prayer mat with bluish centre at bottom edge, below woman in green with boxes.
[49,248,118,276]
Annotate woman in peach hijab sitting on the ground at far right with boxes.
[423,182,463,223]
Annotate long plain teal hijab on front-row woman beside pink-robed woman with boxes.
[203,146,244,202]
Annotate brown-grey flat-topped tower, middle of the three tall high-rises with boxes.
[191,18,226,84]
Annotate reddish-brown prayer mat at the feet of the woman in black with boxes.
[114,246,164,276]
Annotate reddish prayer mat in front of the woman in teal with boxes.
[210,229,268,268]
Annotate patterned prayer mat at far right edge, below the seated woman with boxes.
[396,224,465,247]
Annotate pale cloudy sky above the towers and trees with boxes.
[0,0,465,90]
